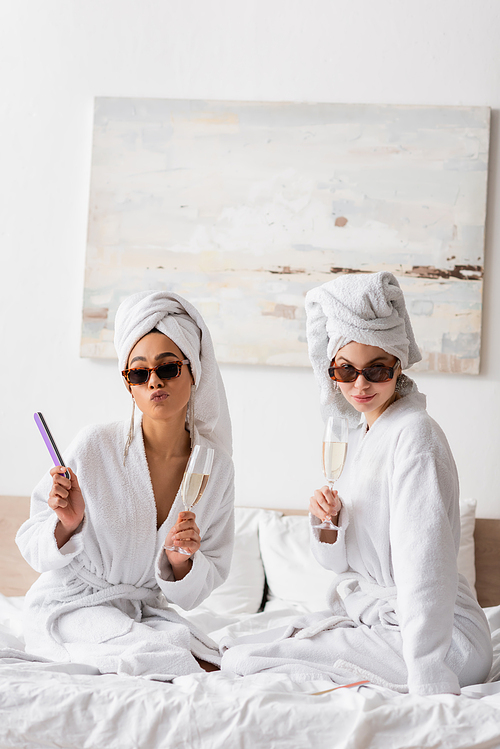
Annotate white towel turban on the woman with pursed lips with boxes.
[114,291,232,455]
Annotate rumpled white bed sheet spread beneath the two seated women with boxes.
[0,596,500,749]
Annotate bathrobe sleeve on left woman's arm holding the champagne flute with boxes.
[156,454,234,611]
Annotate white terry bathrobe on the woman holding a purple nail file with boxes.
[16,422,234,680]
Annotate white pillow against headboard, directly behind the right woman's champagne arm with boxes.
[259,510,335,611]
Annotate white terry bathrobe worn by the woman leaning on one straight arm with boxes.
[222,389,492,694]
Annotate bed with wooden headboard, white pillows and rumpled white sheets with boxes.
[0,497,500,749]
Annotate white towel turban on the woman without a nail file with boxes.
[305,271,422,426]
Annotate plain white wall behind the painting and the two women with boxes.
[0,0,500,517]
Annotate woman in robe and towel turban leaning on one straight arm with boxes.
[222,272,492,695]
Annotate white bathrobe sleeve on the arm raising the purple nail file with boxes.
[16,445,87,572]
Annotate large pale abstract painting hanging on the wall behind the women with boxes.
[81,98,490,374]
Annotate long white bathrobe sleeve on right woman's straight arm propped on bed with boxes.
[390,429,460,695]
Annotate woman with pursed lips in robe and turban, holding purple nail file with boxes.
[17,292,234,680]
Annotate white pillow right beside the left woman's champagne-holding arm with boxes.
[202,507,265,615]
